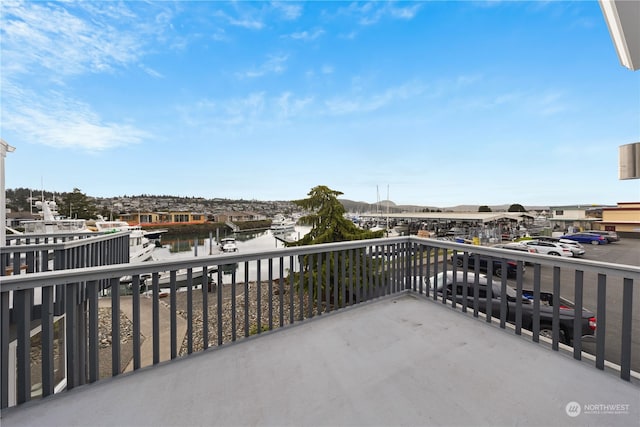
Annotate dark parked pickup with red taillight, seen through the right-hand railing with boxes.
[429,271,596,345]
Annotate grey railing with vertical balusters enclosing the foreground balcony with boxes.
[0,237,640,408]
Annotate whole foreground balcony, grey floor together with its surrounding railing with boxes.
[0,237,640,426]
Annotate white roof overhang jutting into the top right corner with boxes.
[598,0,640,71]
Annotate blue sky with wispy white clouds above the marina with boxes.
[0,0,640,207]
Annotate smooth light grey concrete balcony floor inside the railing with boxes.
[0,294,640,427]
